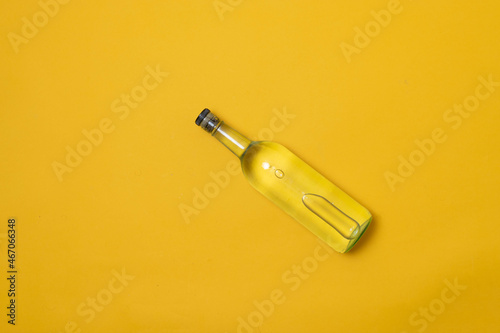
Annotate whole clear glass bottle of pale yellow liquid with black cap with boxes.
[196,109,372,253]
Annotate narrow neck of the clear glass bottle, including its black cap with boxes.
[195,112,252,158]
